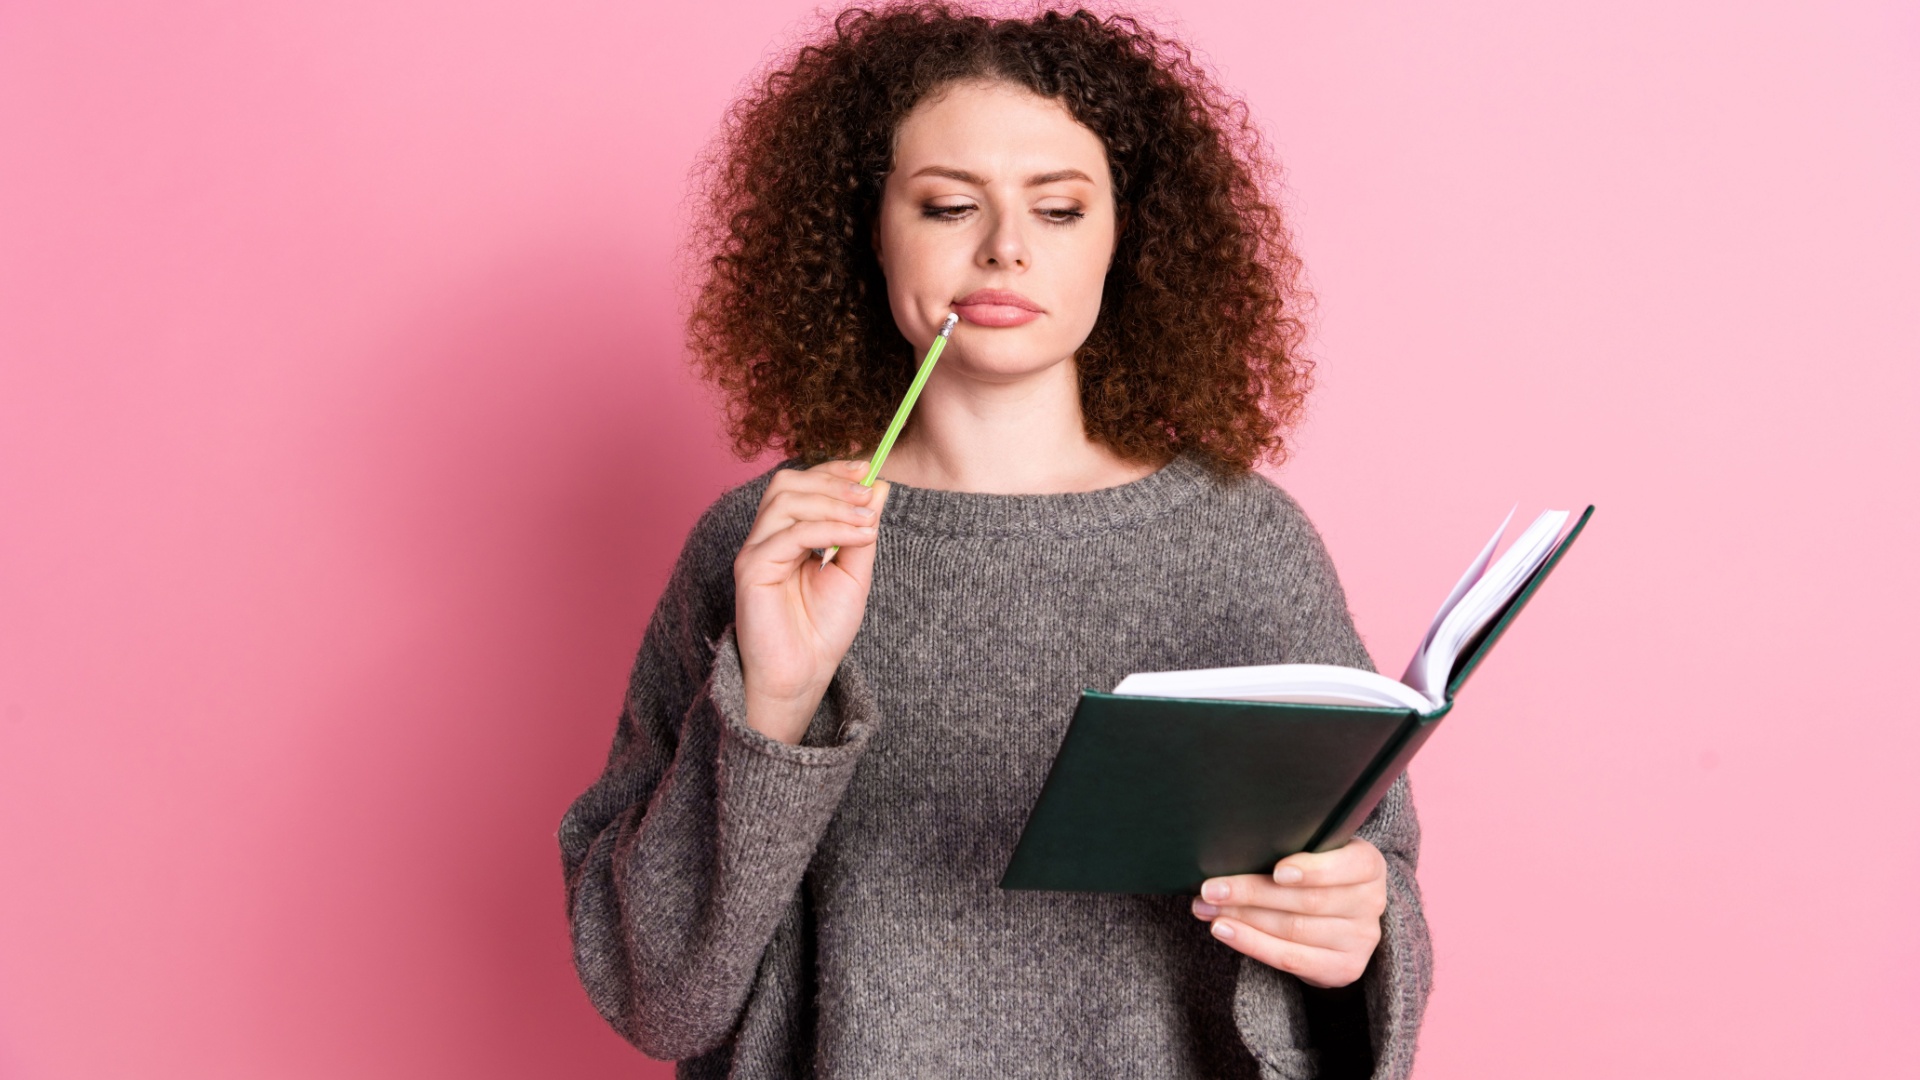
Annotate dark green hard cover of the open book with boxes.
[1000,505,1594,894]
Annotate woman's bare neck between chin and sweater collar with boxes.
[881,359,1158,494]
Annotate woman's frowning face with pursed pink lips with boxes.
[874,83,1117,380]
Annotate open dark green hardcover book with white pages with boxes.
[1000,507,1594,894]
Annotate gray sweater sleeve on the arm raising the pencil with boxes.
[559,503,877,1059]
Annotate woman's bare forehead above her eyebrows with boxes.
[893,83,1108,186]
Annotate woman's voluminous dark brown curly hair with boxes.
[687,2,1311,473]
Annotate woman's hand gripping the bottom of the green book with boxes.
[1194,838,1386,988]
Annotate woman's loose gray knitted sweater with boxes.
[561,457,1432,1080]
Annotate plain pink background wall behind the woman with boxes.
[0,0,1920,1080]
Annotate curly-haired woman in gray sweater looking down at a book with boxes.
[561,6,1430,1076]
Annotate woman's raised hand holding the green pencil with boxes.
[733,461,887,744]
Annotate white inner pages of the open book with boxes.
[1114,509,1571,713]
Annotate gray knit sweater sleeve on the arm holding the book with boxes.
[1235,500,1432,1080]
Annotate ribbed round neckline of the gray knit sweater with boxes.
[881,454,1210,536]
